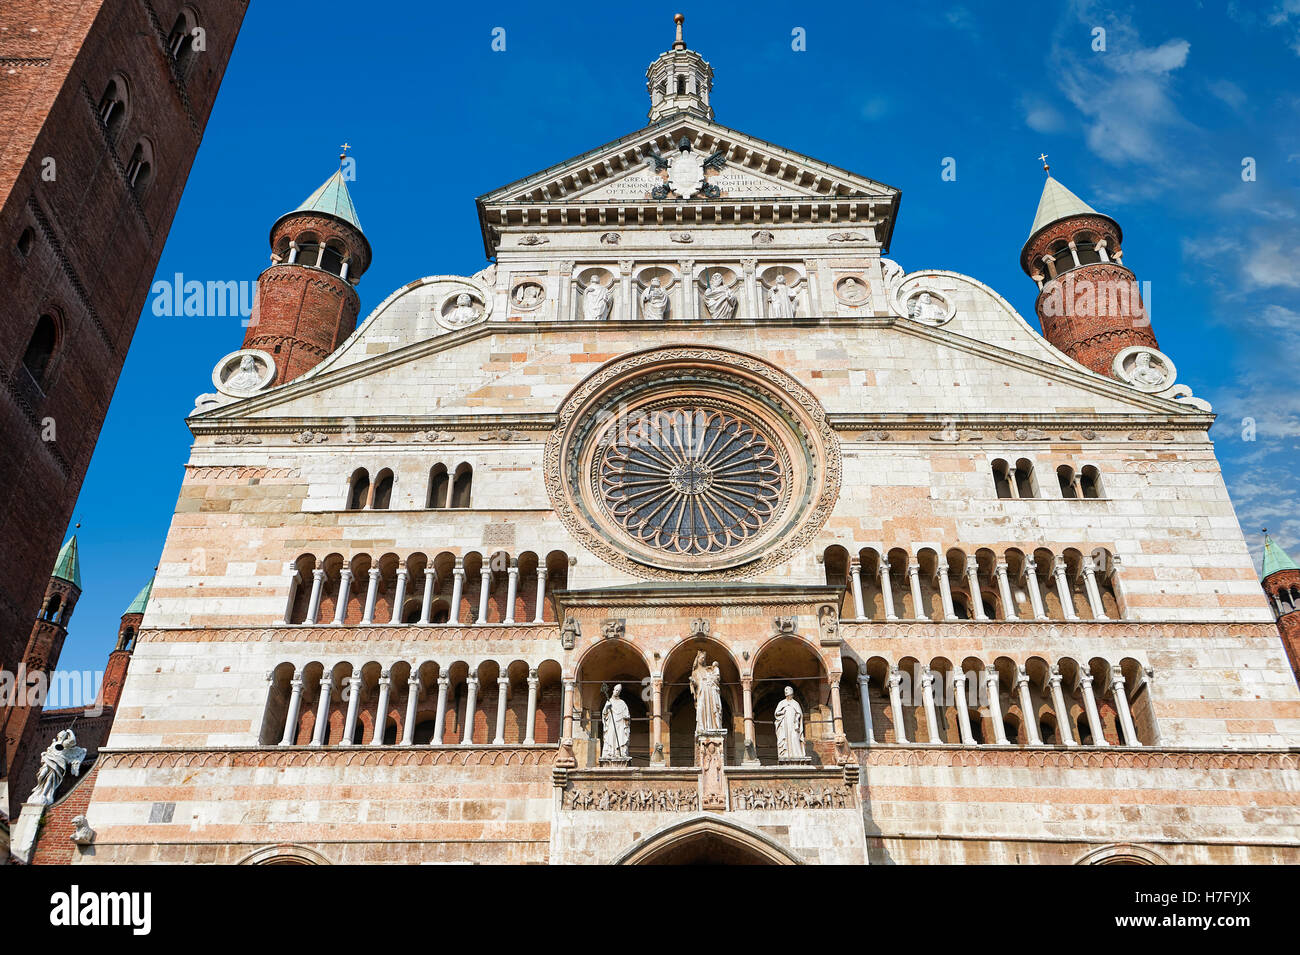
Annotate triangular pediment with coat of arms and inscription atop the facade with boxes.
[478,114,900,210]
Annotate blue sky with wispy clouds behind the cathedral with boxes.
[50,0,1300,701]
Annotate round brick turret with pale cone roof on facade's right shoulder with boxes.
[1021,162,1158,377]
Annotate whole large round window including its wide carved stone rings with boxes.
[546,347,841,578]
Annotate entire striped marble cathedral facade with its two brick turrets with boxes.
[78,18,1300,864]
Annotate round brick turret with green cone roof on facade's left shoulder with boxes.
[243,156,371,385]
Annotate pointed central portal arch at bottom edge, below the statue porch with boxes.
[614,815,803,865]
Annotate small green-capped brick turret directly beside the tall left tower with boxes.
[0,535,82,819]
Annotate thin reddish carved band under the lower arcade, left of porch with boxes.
[99,743,556,770]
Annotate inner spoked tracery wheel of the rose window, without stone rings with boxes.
[594,405,787,556]
